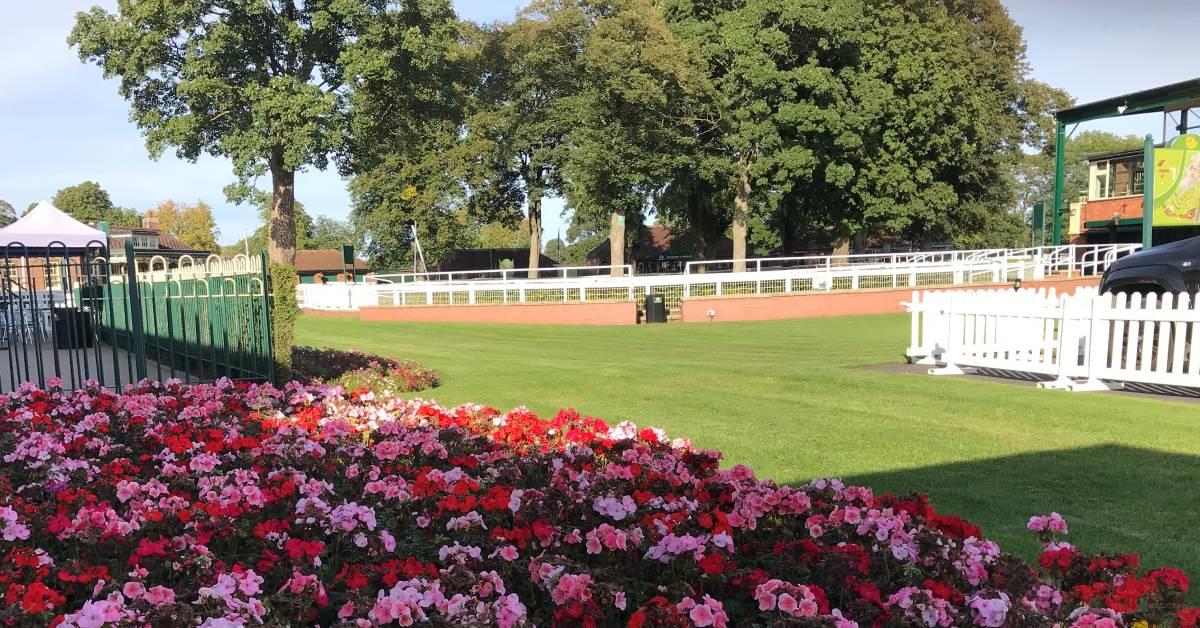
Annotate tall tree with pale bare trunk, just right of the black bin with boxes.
[665,0,863,270]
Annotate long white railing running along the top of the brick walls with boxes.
[296,245,1126,310]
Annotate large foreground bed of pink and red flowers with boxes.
[0,382,1196,628]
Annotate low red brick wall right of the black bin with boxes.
[683,277,1099,323]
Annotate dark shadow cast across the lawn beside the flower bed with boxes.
[844,444,1200,576]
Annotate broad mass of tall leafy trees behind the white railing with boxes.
[68,0,1082,273]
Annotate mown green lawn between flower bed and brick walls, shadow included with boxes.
[298,316,1200,581]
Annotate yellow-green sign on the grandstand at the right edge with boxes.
[1153,134,1200,227]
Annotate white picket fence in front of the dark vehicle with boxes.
[906,288,1200,390]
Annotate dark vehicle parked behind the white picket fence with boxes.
[1100,237,1200,294]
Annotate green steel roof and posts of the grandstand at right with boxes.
[1052,78,1200,249]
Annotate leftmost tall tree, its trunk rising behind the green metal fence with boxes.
[68,0,458,264]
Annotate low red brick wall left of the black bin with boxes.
[358,303,637,325]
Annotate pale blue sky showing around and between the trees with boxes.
[0,0,1200,243]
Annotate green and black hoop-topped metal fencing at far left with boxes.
[0,239,274,390]
